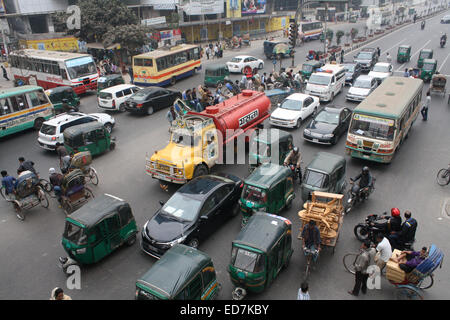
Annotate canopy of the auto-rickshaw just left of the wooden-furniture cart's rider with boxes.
[233,212,291,253]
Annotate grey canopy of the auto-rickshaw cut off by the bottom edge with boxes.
[136,244,212,299]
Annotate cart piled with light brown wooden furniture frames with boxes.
[298,191,344,253]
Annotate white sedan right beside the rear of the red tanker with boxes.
[269,93,320,128]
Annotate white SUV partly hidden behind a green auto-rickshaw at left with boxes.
[38,112,116,150]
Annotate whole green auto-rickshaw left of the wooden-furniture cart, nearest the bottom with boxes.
[227,212,293,300]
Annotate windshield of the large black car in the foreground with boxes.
[161,192,202,221]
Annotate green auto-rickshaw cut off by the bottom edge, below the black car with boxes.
[135,244,221,300]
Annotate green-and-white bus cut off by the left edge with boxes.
[0,86,55,138]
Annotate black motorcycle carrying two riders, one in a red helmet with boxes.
[353,212,415,251]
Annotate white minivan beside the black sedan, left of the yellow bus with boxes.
[97,84,141,112]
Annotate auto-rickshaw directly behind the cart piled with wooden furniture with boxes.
[302,152,346,201]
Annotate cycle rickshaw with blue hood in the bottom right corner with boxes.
[388,244,444,300]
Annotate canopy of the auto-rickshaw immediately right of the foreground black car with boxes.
[244,163,291,189]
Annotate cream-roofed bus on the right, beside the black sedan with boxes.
[345,77,423,163]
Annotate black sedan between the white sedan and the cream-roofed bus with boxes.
[303,106,352,145]
